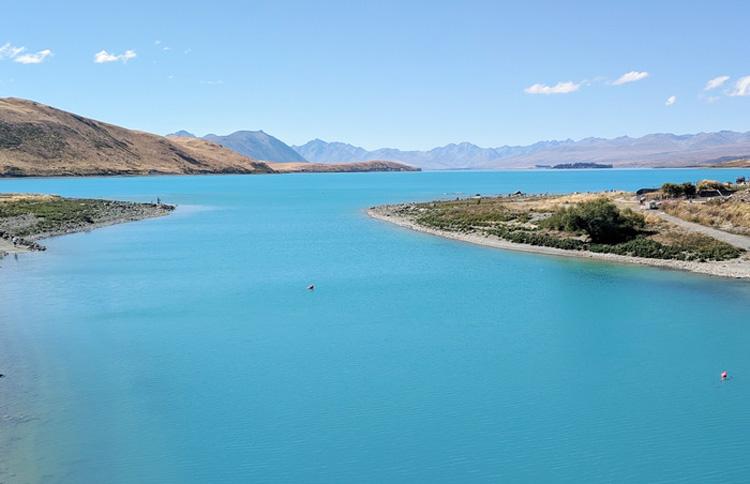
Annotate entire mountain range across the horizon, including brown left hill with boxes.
[0,98,750,176]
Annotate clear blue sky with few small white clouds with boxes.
[0,0,750,149]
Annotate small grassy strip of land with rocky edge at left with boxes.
[0,194,175,250]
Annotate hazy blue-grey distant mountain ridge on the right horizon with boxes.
[293,131,750,169]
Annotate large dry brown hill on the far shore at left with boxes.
[0,98,272,176]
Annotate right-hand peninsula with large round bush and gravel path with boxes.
[368,182,750,279]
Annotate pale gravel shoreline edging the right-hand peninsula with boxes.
[367,205,750,281]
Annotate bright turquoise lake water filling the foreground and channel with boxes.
[0,170,750,483]
